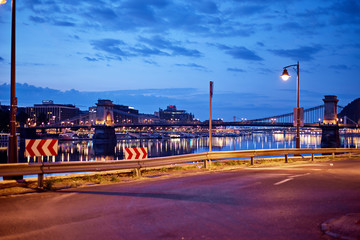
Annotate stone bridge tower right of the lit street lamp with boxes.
[320,95,340,148]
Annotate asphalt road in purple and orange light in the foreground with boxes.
[0,160,360,240]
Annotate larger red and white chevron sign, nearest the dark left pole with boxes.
[25,139,58,157]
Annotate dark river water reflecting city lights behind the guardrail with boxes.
[0,131,360,163]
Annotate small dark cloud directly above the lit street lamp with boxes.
[269,46,322,61]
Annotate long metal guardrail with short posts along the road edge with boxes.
[0,148,360,187]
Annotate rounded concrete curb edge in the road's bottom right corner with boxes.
[321,213,360,240]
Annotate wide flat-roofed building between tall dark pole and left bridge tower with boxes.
[26,100,80,125]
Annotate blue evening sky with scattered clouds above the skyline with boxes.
[0,0,360,121]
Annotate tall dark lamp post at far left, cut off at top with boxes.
[0,0,18,163]
